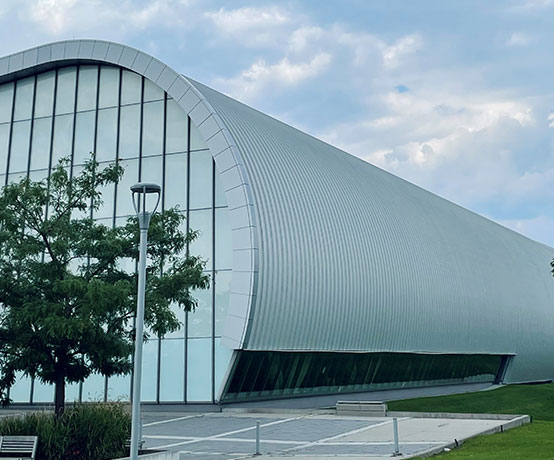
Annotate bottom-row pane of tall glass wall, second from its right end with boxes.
[187,339,212,401]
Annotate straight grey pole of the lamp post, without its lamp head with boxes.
[129,228,149,460]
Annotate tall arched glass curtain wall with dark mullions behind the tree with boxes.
[0,65,231,402]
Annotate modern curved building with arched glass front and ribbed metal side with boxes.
[0,40,554,403]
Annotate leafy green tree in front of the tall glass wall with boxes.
[0,158,209,415]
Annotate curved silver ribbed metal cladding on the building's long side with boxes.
[192,82,554,381]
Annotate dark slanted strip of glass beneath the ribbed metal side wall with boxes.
[222,351,503,402]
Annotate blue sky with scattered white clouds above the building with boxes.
[0,0,554,246]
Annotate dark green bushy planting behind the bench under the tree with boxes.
[0,403,131,460]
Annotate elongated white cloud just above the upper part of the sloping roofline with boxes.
[217,53,331,101]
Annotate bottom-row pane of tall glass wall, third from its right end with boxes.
[160,339,185,401]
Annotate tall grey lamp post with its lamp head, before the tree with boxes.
[130,182,162,460]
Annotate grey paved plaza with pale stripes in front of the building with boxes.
[143,413,524,460]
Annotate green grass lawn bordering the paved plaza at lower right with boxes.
[388,384,554,460]
